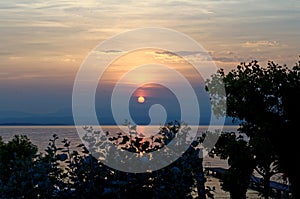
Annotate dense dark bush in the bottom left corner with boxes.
[0,135,38,198]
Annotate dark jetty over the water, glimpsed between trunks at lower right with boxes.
[204,167,291,199]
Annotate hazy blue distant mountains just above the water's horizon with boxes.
[0,109,237,125]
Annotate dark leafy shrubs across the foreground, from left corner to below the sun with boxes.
[0,122,206,198]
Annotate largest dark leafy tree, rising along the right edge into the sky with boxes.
[207,61,300,198]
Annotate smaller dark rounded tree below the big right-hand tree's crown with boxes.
[210,132,255,199]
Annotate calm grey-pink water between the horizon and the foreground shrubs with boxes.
[0,126,238,171]
